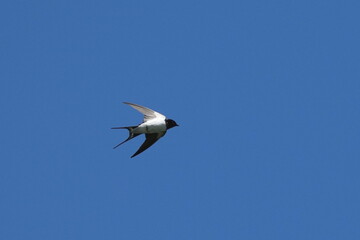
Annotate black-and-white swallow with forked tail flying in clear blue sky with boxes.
[111,102,179,158]
